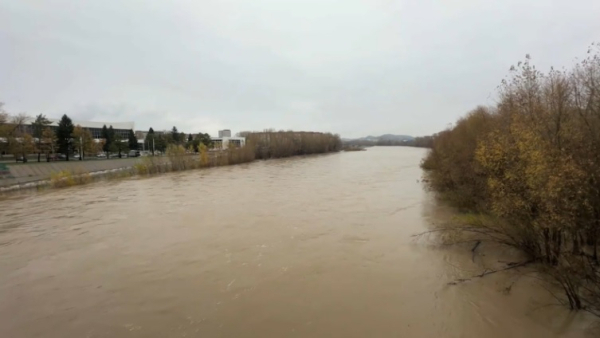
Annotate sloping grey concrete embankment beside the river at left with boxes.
[0,157,141,190]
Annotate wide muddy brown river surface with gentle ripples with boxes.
[0,147,590,338]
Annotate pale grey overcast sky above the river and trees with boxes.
[0,0,600,137]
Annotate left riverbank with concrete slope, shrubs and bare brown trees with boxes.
[0,131,341,192]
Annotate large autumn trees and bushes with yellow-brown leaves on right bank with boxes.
[422,46,600,314]
